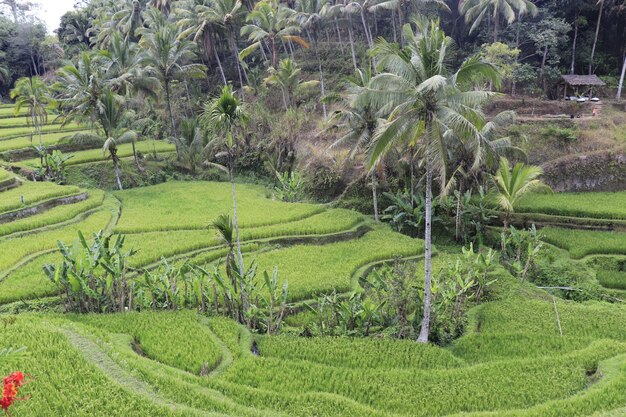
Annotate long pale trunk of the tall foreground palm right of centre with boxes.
[417,135,433,343]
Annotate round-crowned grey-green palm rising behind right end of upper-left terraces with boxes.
[139,14,206,136]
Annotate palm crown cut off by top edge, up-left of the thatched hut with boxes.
[459,0,538,42]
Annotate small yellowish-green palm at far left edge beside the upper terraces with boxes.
[11,77,51,148]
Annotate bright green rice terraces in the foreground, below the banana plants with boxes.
[0,297,626,417]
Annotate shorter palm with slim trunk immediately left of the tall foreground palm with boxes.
[330,68,381,221]
